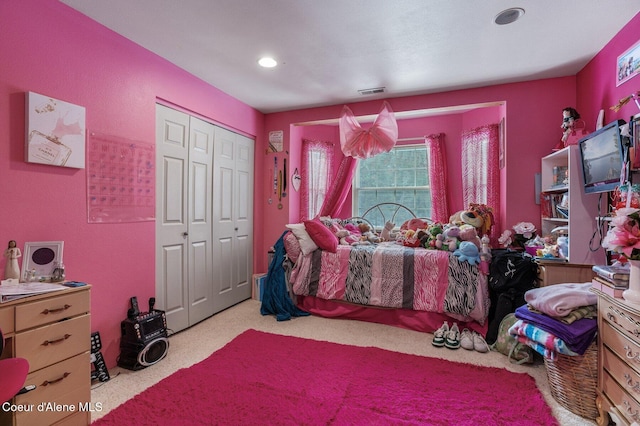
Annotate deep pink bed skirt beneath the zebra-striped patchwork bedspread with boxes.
[297,296,488,336]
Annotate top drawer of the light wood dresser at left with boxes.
[15,291,91,332]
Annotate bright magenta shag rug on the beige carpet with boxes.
[93,330,558,426]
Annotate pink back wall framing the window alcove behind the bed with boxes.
[256,76,576,270]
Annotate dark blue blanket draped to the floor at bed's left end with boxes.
[260,230,309,321]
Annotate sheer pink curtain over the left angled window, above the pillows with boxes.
[300,139,333,220]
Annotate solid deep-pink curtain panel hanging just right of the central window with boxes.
[424,133,450,223]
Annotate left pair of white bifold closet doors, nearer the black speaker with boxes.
[156,105,215,331]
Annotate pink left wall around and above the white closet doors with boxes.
[0,0,264,366]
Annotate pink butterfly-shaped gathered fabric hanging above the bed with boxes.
[339,101,398,158]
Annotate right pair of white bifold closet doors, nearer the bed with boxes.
[213,128,254,312]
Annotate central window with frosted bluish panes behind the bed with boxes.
[353,144,431,227]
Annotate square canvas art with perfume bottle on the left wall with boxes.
[25,92,86,169]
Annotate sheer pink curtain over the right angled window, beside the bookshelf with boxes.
[462,124,500,241]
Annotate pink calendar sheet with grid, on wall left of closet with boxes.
[87,132,155,223]
